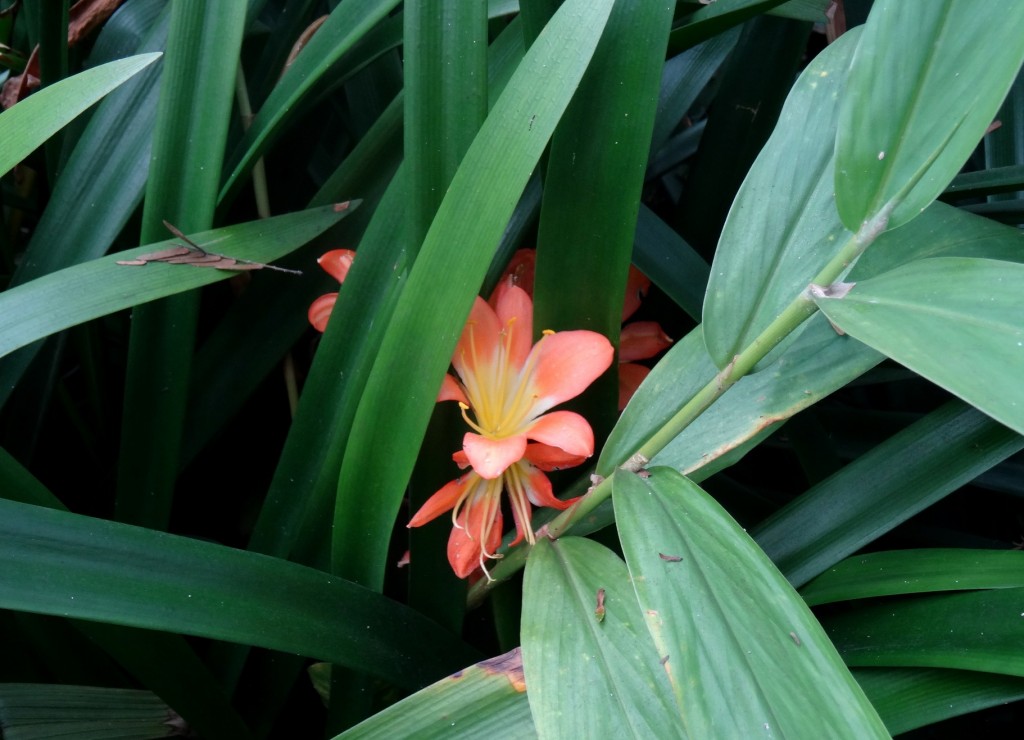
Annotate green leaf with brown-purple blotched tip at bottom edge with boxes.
[338,648,537,740]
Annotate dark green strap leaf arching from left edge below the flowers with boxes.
[0,500,477,688]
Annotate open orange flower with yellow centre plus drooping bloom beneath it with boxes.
[409,286,613,577]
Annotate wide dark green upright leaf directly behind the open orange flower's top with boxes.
[534,0,673,439]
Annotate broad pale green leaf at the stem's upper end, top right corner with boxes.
[836,0,1024,231]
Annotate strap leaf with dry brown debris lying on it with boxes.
[0,204,348,356]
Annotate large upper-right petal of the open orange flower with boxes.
[531,330,614,413]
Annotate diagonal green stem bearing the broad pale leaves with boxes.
[468,201,895,607]
